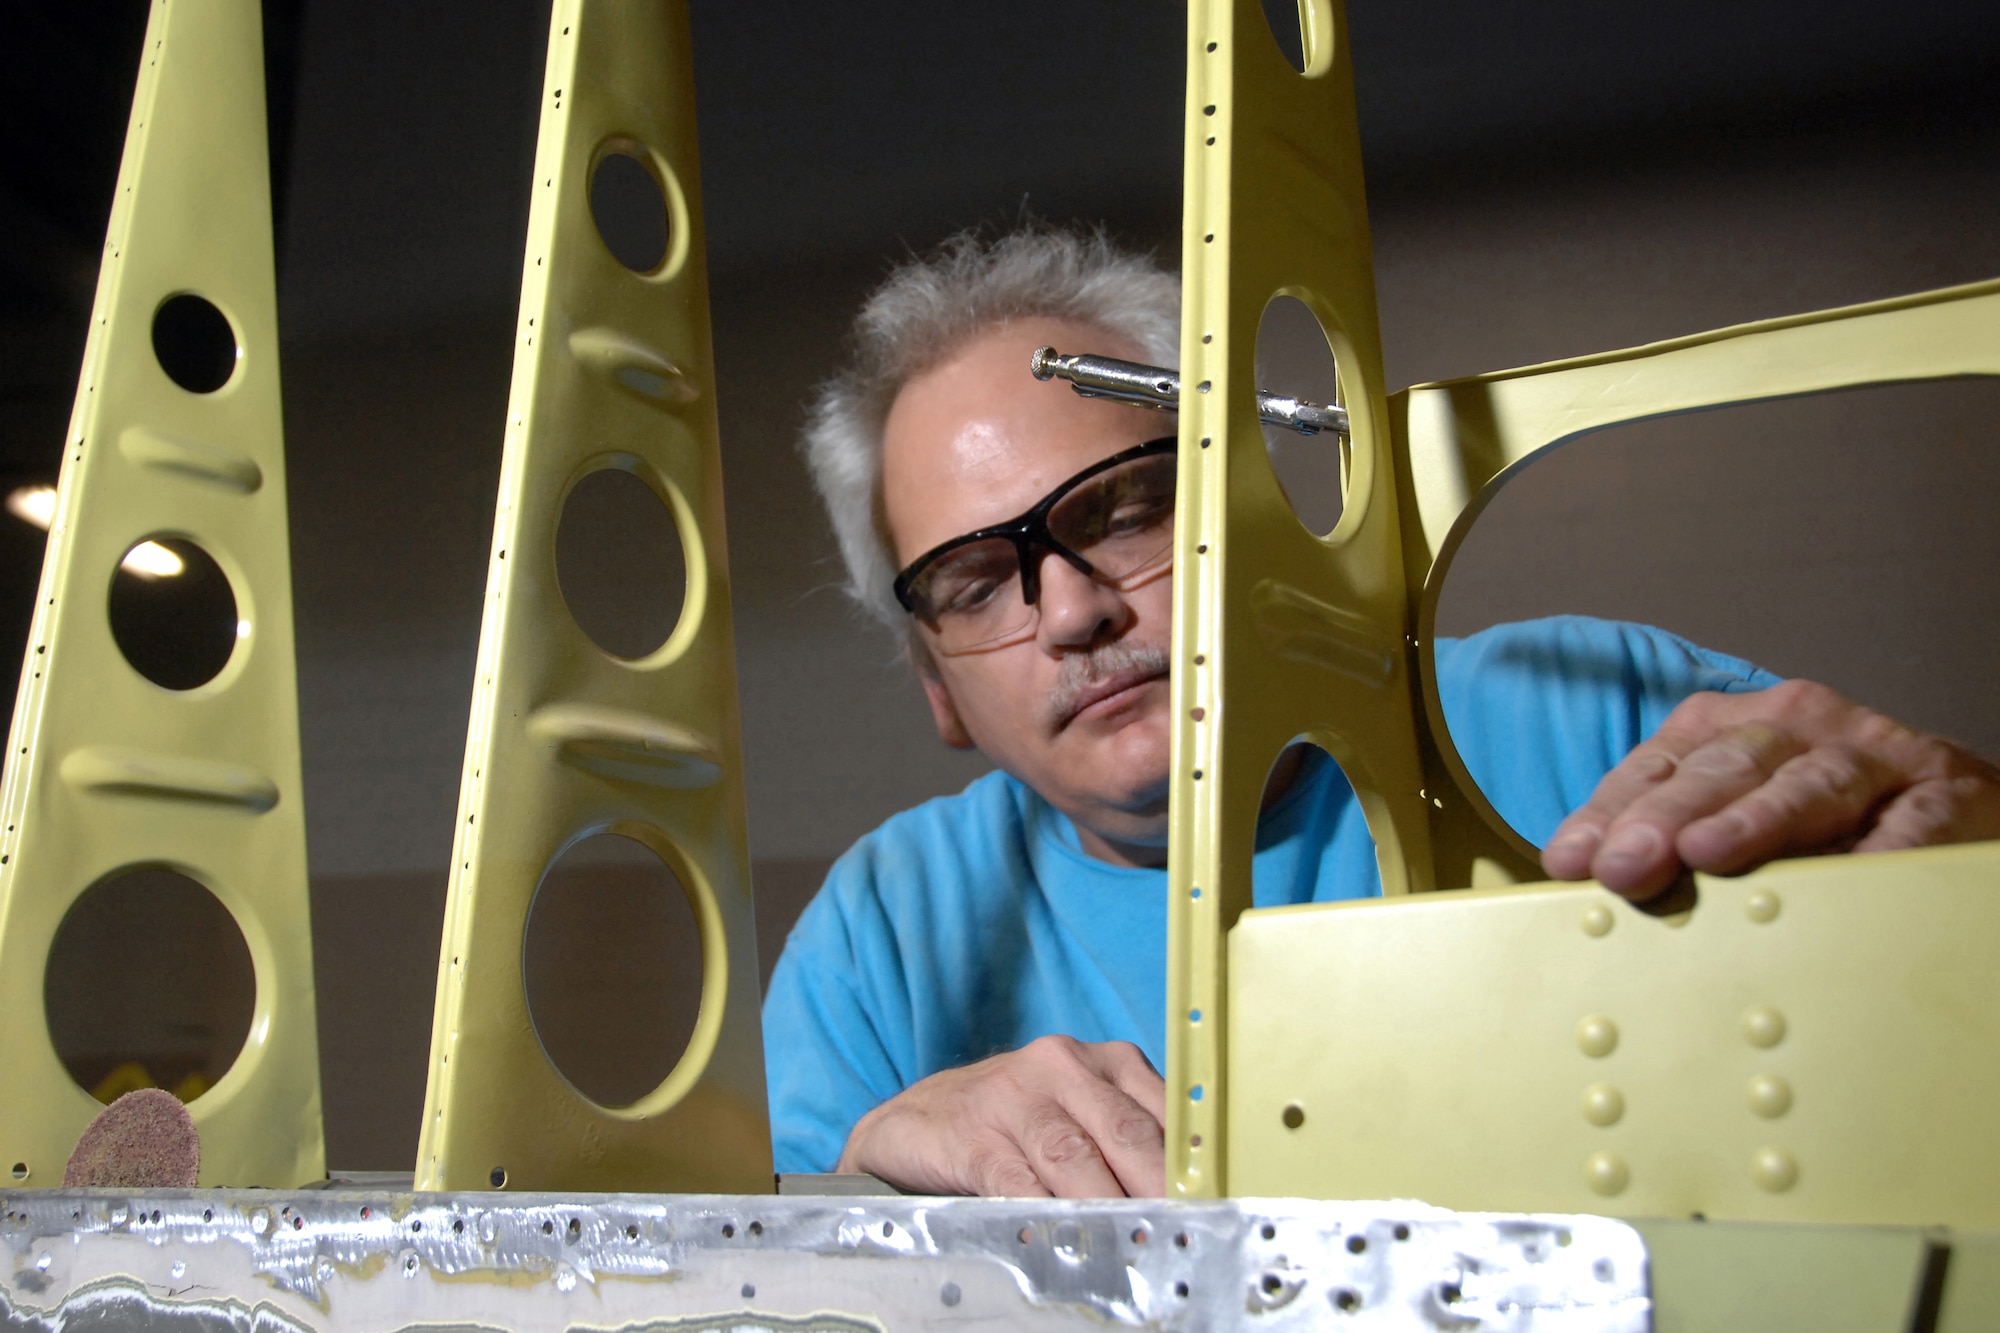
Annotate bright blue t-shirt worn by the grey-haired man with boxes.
[764,616,1778,1171]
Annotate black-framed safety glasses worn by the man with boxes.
[896,436,1178,652]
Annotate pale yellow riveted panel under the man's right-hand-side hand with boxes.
[1230,843,2000,1229]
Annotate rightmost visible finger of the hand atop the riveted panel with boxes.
[1676,745,1916,875]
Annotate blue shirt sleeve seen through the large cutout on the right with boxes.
[1436,616,1778,847]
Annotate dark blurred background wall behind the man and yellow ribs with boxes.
[0,0,2000,1169]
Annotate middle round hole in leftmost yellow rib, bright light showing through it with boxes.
[106,536,250,691]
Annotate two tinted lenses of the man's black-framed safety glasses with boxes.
[910,454,1176,652]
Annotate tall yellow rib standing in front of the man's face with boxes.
[1166,0,1526,1197]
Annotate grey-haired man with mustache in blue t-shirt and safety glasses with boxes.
[764,228,2000,1195]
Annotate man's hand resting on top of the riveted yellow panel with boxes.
[1542,681,2000,901]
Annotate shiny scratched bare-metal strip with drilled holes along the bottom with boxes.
[0,1191,1650,1333]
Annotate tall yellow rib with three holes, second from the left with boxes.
[416,0,772,1193]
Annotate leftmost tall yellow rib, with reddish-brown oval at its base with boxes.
[0,0,326,1187]
